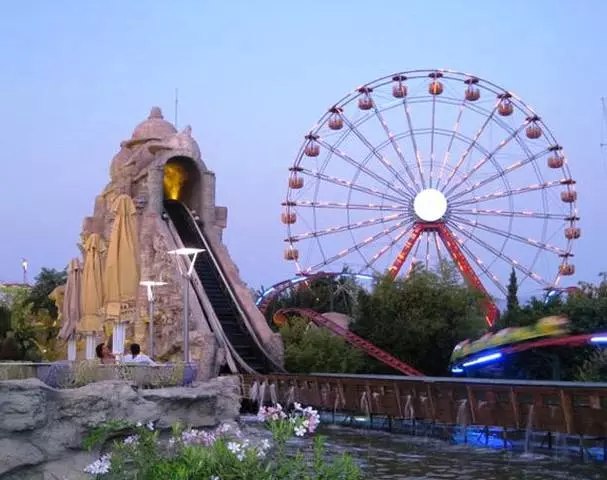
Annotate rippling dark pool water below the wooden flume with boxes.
[247,425,607,480]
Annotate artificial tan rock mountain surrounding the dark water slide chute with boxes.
[75,107,284,377]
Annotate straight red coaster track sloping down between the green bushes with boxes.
[276,308,423,377]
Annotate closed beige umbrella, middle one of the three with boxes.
[76,233,105,334]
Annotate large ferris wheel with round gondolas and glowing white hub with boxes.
[281,70,581,322]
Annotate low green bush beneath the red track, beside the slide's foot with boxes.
[280,318,365,373]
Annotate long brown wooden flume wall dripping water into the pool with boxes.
[241,374,607,438]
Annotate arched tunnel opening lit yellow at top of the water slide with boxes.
[163,157,201,209]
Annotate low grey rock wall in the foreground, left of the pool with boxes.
[0,377,240,480]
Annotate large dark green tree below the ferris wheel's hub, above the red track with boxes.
[353,263,484,375]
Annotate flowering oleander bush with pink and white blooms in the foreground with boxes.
[85,404,363,480]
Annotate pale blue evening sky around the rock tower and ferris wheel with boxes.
[0,0,607,296]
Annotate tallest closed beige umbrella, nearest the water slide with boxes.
[103,194,140,354]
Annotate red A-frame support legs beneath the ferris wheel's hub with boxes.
[388,222,498,327]
